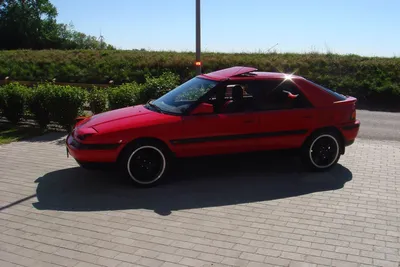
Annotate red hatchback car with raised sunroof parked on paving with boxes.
[67,67,360,186]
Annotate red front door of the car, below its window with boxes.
[173,84,260,156]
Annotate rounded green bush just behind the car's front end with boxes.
[49,85,88,131]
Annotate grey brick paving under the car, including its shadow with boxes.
[0,134,400,267]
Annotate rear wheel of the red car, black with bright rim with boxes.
[301,131,342,171]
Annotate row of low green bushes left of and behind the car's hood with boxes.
[0,72,179,130]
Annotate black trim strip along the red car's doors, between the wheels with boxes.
[170,129,308,145]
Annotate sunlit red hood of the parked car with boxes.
[81,105,152,128]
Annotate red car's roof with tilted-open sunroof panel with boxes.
[199,66,301,81]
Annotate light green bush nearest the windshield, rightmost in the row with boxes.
[139,72,180,103]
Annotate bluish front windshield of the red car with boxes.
[151,77,218,114]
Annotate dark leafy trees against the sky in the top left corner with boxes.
[0,0,115,50]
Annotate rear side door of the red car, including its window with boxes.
[255,80,315,149]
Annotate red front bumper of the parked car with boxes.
[66,134,121,163]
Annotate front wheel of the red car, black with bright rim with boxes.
[120,141,172,187]
